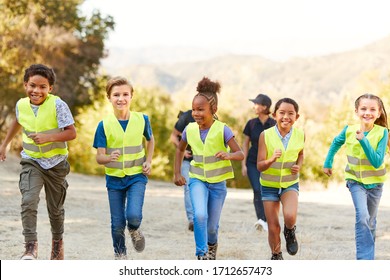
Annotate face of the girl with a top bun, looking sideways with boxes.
[192,95,216,129]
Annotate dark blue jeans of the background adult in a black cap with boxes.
[246,162,267,221]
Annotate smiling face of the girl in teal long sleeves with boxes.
[355,98,381,128]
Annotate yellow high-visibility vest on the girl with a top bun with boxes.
[186,120,234,183]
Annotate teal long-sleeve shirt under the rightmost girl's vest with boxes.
[324,126,389,187]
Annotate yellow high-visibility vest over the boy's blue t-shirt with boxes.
[103,112,145,178]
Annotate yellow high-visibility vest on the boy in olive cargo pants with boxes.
[18,94,68,158]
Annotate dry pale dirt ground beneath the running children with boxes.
[0,156,390,260]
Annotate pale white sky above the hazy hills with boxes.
[82,0,390,60]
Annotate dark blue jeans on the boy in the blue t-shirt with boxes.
[107,182,146,255]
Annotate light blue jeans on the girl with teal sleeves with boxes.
[347,180,383,260]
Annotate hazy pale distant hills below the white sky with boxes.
[99,36,390,116]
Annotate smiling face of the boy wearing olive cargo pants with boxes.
[24,75,53,105]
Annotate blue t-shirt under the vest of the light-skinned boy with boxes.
[93,115,153,190]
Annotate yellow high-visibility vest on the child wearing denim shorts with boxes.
[260,127,305,188]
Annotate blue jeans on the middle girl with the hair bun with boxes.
[189,178,227,256]
